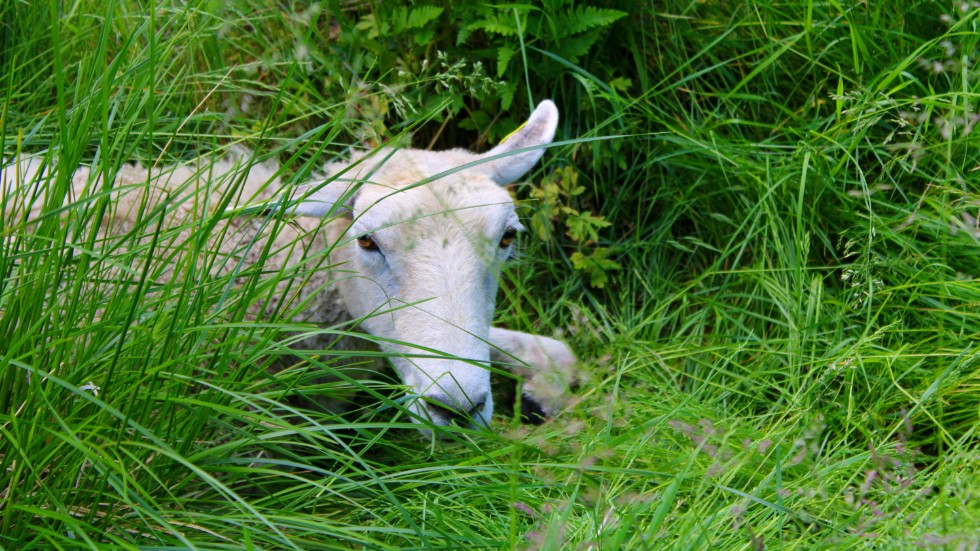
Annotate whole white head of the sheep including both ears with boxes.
[294,101,558,432]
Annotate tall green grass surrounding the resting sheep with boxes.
[0,0,980,550]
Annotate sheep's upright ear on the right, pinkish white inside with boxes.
[476,100,558,185]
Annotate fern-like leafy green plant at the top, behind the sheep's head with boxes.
[310,0,627,145]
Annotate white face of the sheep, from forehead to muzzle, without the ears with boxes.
[342,174,522,425]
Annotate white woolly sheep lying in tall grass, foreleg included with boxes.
[0,100,576,432]
